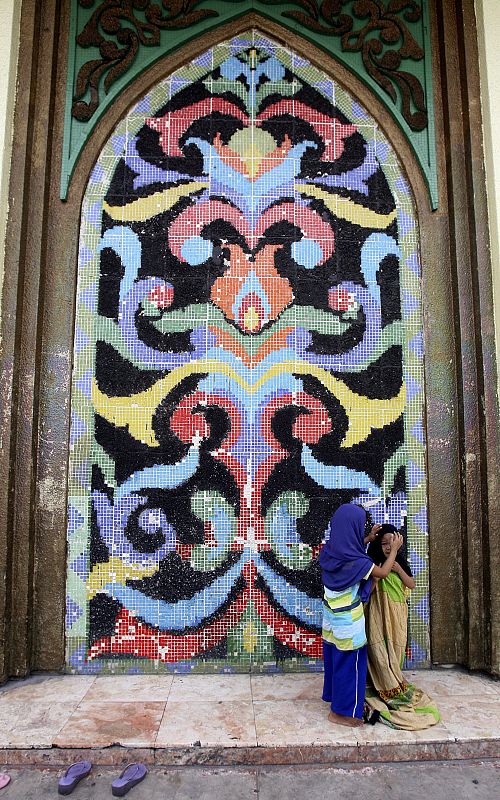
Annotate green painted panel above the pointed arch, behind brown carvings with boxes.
[61,0,438,208]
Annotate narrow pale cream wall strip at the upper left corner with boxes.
[0,0,21,310]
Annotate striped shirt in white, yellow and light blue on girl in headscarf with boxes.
[322,567,373,650]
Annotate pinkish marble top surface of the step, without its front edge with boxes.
[0,669,500,752]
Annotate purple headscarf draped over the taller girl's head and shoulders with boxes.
[319,503,373,602]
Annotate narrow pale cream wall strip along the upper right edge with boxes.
[476,0,500,394]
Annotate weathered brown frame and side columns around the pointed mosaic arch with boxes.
[0,0,500,675]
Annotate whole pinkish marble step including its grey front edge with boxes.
[0,669,500,766]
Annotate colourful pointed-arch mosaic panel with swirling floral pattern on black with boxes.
[67,31,429,672]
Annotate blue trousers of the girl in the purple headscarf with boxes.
[323,639,368,719]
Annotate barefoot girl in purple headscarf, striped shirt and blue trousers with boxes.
[319,503,403,728]
